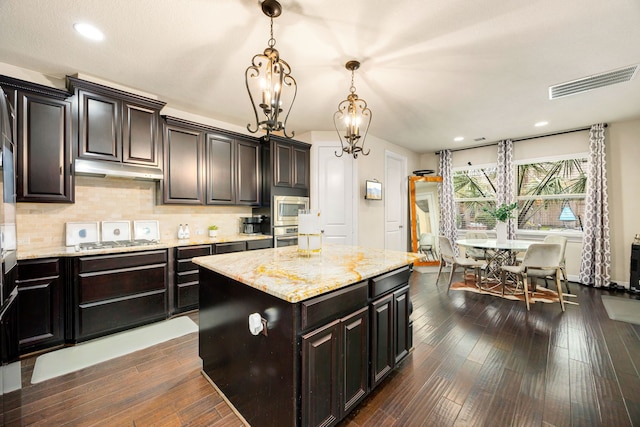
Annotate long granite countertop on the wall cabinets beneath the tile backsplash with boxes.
[18,234,272,260]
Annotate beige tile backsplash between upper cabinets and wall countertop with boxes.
[16,176,251,250]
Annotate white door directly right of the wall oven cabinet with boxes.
[311,143,357,245]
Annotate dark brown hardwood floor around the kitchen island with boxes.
[4,272,640,427]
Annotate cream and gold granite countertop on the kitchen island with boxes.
[193,244,425,303]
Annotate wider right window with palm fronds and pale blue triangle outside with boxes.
[516,157,588,231]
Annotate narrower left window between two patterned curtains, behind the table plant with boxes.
[453,166,497,230]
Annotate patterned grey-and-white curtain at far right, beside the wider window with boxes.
[579,123,611,288]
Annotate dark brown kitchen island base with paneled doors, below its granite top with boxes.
[199,267,411,427]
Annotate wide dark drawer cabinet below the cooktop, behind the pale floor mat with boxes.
[74,249,168,342]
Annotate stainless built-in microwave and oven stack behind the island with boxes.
[271,196,309,248]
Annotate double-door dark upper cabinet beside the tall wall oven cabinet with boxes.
[206,133,261,206]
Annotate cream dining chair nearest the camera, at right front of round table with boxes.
[501,243,564,311]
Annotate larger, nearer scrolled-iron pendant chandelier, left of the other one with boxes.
[245,0,298,140]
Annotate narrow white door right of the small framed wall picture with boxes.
[384,151,408,251]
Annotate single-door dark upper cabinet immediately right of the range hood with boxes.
[161,117,205,205]
